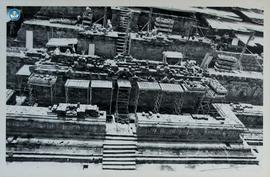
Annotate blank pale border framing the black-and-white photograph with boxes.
[0,0,270,177]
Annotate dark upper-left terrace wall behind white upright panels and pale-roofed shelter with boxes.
[18,24,117,58]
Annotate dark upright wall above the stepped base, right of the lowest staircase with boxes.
[137,123,242,142]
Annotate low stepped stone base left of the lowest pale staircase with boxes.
[6,141,103,163]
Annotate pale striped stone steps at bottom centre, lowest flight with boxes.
[102,134,137,170]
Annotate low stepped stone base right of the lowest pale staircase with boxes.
[136,141,258,165]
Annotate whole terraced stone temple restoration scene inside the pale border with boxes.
[6,6,264,171]
